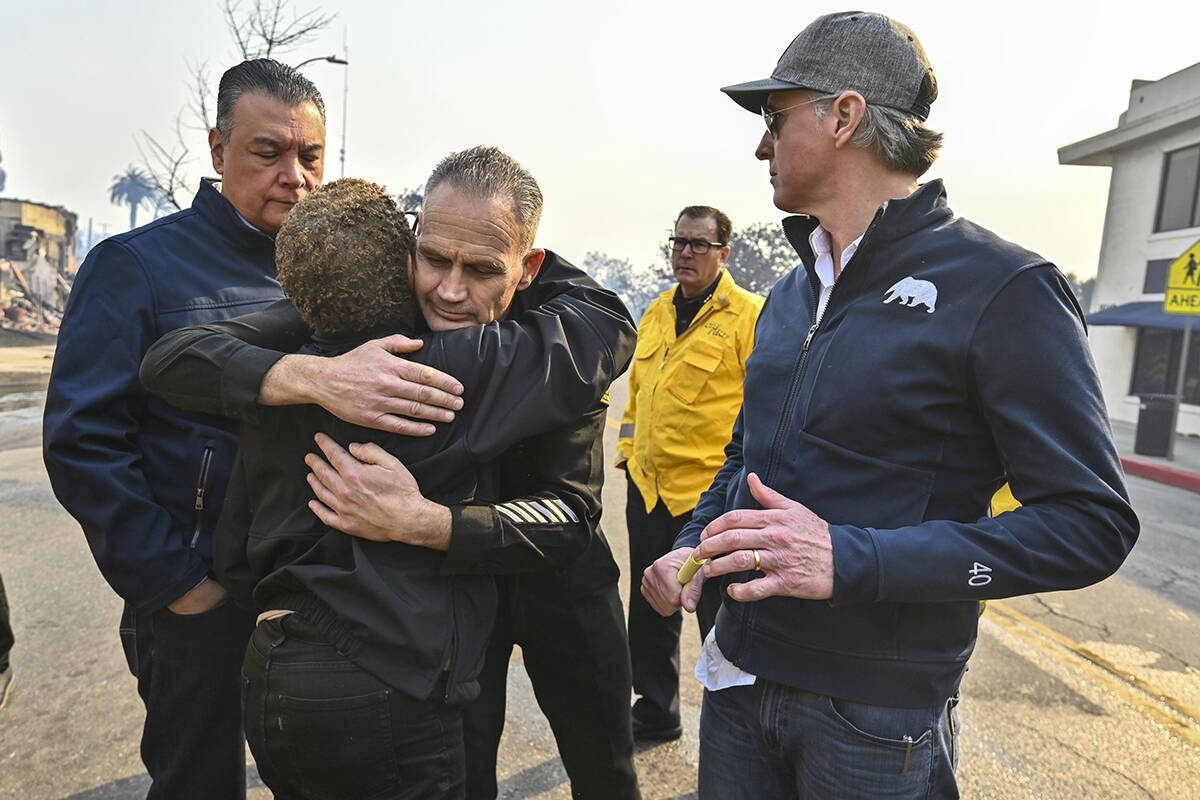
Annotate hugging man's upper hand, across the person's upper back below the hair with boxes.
[258,333,462,437]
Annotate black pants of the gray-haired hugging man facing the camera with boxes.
[463,576,641,800]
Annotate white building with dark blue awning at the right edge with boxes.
[1058,64,1200,434]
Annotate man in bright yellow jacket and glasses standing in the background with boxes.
[617,205,763,740]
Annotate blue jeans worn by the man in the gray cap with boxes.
[700,678,959,800]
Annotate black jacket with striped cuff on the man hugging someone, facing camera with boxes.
[142,251,637,590]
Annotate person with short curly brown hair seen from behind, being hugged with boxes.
[224,179,625,800]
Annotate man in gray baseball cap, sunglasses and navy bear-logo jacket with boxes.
[642,12,1138,800]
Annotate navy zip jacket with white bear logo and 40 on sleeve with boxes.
[677,181,1138,708]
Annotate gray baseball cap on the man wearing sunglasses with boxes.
[721,11,937,120]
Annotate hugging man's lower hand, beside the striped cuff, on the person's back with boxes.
[305,433,450,551]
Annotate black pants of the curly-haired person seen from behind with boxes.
[242,614,466,800]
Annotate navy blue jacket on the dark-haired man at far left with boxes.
[42,181,283,612]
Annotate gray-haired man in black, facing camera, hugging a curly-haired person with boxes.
[143,148,637,798]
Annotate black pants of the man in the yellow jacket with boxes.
[625,476,721,728]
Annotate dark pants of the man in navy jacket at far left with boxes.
[121,601,254,800]
